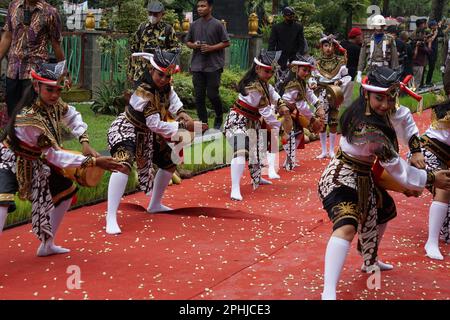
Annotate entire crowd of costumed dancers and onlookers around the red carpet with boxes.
[0,0,450,299]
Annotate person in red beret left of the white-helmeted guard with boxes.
[341,28,363,107]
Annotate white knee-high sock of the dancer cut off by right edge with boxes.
[425,201,448,260]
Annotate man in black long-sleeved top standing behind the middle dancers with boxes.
[268,7,306,69]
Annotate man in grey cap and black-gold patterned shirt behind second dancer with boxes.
[128,1,181,87]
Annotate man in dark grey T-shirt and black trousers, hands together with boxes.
[186,0,230,129]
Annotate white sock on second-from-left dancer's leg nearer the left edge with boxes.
[106,172,128,234]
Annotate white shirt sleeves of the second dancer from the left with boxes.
[130,88,183,138]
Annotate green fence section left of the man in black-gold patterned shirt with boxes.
[101,38,128,82]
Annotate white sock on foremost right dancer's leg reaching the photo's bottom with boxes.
[322,236,350,300]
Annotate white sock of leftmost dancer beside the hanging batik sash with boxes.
[37,198,72,257]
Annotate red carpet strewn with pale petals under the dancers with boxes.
[0,111,450,300]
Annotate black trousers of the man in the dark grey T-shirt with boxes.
[192,69,223,128]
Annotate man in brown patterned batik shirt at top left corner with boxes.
[0,0,64,116]
